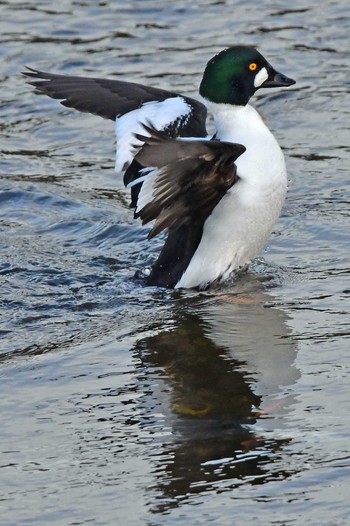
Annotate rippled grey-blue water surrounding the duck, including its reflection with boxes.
[0,0,350,526]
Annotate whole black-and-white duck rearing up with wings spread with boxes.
[23,45,295,290]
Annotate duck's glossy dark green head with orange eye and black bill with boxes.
[199,46,295,106]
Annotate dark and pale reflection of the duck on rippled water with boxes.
[135,294,299,512]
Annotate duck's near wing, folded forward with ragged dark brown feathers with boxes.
[129,125,245,238]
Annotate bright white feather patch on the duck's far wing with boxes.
[115,97,192,172]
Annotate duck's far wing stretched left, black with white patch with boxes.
[23,68,207,175]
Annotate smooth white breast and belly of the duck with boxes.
[176,104,287,288]
